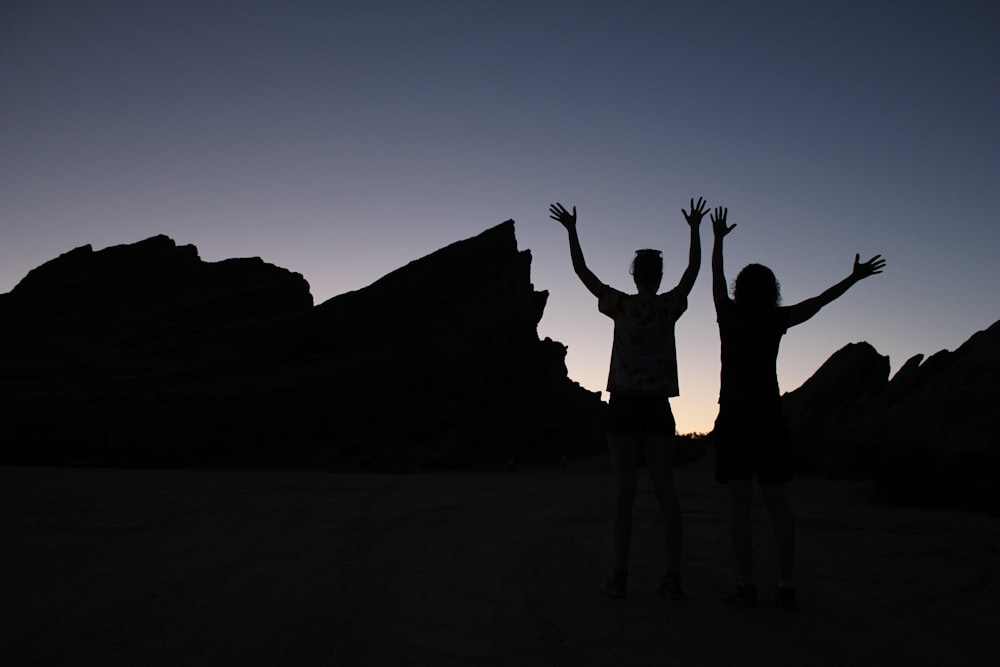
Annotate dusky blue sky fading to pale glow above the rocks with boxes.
[0,0,1000,433]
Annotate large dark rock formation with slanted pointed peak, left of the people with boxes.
[0,221,604,469]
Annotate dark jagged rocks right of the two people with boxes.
[783,322,1000,512]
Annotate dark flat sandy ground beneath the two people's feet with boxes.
[0,459,1000,666]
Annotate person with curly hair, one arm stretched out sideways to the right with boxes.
[711,207,885,607]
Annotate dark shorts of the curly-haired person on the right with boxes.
[713,405,792,484]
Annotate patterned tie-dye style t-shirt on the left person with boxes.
[597,285,687,396]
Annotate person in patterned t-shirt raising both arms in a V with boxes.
[549,197,707,598]
